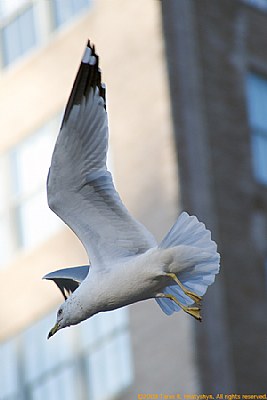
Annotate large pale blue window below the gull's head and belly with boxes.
[0,308,132,400]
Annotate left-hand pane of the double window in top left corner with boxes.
[1,2,37,66]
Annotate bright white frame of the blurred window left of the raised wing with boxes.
[0,113,63,268]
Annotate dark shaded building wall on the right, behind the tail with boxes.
[162,0,267,394]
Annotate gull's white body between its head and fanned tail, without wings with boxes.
[66,245,218,319]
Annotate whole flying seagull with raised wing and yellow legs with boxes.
[44,41,220,338]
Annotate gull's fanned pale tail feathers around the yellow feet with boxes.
[156,212,220,315]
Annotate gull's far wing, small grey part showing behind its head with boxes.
[43,265,90,300]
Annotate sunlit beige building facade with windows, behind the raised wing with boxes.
[0,0,198,400]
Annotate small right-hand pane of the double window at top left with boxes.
[52,0,91,27]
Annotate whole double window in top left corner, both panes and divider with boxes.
[0,0,91,67]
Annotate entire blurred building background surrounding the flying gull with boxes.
[0,0,267,400]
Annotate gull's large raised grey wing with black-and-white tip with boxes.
[47,42,156,266]
